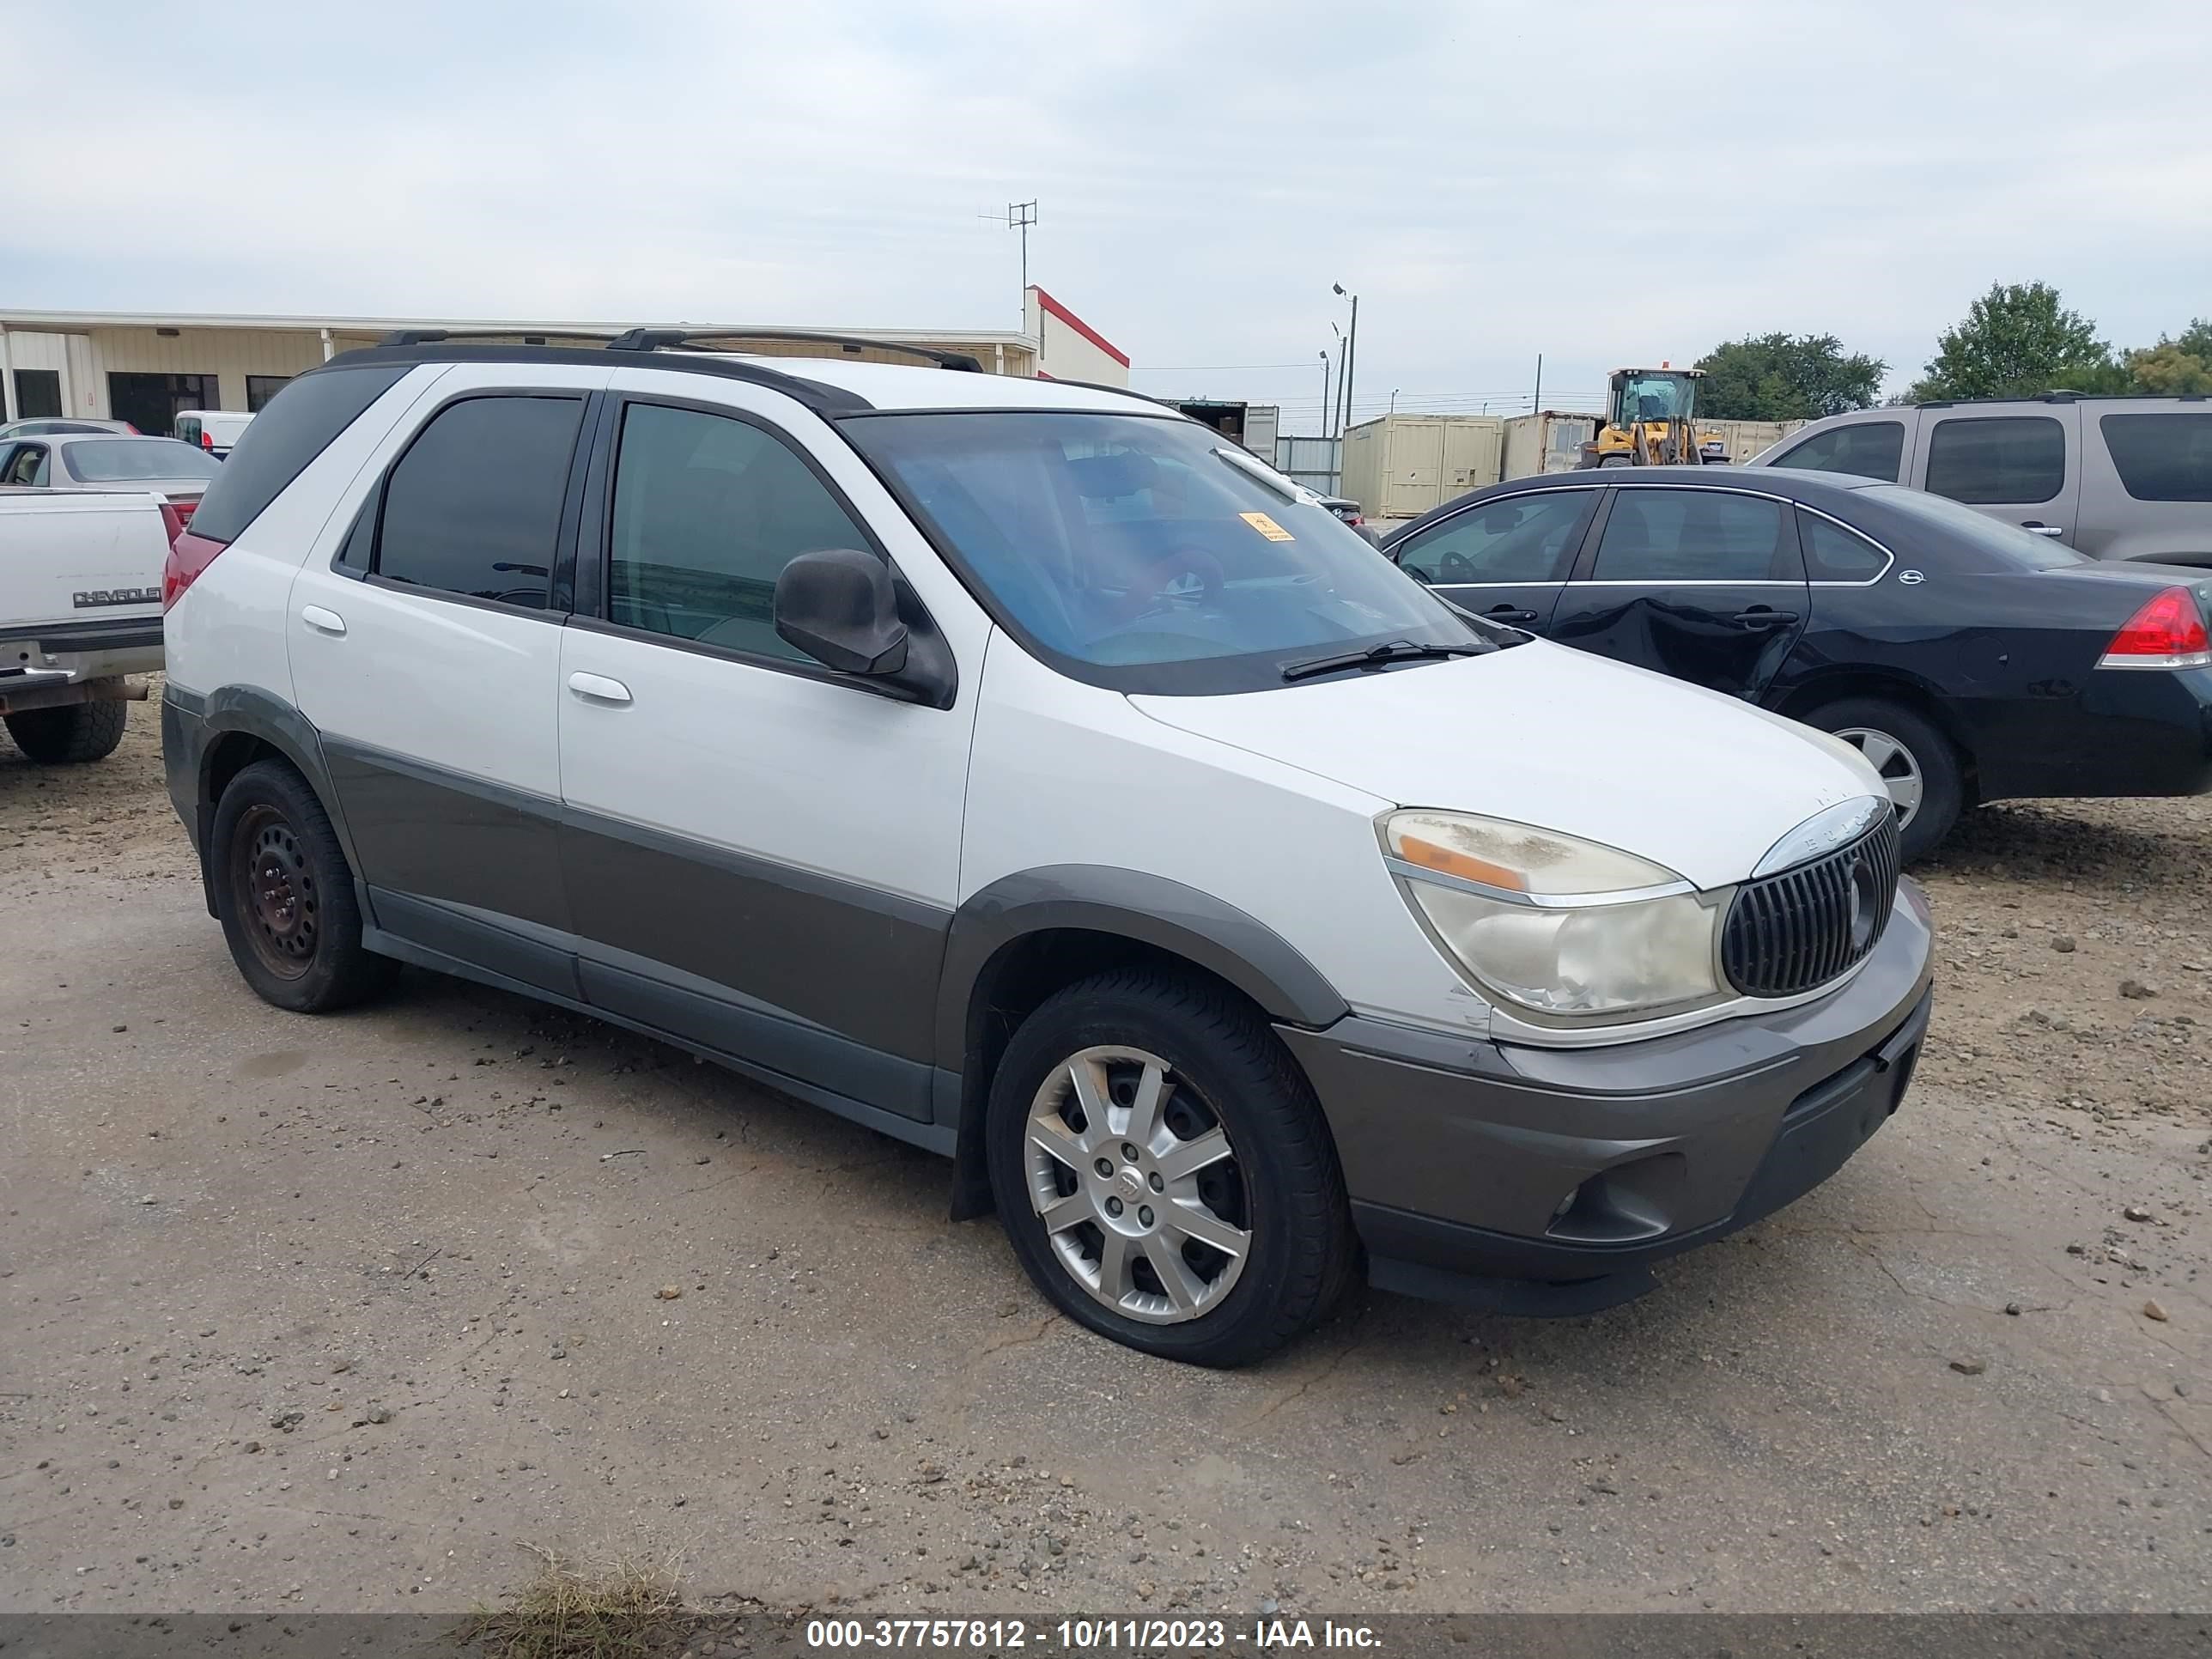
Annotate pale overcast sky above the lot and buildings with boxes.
[0,0,2212,431]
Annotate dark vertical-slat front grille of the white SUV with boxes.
[1721,811,1900,998]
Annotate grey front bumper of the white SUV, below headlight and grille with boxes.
[1279,880,1931,1314]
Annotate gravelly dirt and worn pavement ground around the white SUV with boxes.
[0,706,2212,1614]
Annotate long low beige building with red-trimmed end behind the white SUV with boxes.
[0,288,1128,434]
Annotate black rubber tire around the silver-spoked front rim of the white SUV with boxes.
[984,969,1358,1364]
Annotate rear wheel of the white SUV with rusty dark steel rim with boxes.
[208,761,398,1013]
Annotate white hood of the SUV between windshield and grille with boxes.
[1130,639,1882,887]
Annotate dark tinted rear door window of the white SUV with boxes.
[380,396,584,608]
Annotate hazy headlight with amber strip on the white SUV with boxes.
[1382,811,1725,1022]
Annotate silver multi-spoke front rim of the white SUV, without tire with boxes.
[1024,1046,1252,1325]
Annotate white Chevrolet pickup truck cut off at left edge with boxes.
[0,489,175,765]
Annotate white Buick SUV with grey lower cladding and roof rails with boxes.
[164,330,1929,1364]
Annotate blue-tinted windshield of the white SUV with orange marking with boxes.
[841,411,1493,692]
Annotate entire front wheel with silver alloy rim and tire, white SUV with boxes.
[982,967,1358,1364]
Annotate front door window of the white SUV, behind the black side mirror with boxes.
[606,403,872,661]
